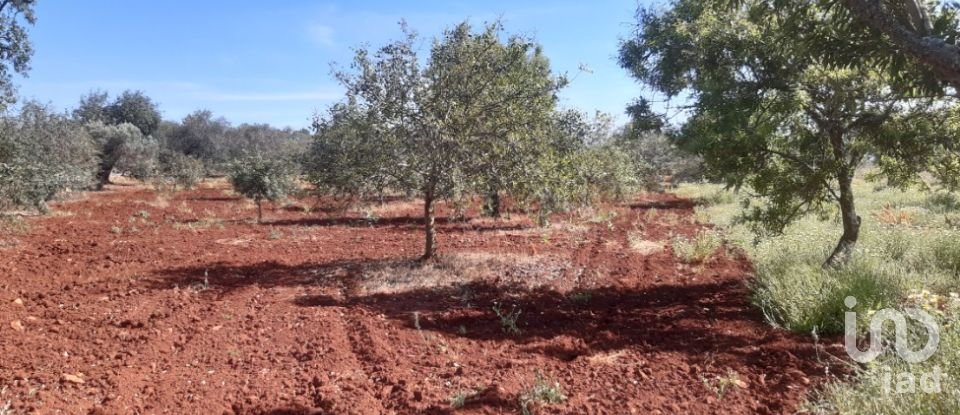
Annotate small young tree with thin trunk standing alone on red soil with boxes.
[229,155,297,223]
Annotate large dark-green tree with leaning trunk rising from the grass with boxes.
[620,0,956,266]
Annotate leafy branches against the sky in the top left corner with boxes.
[0,0,37,110]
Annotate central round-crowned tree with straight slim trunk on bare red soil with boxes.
[317,23,565,259]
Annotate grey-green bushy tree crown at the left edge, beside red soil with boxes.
[0,102,97,212]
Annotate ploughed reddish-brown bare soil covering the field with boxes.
[0,186,836,414]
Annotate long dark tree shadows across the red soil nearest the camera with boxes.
[147,259,820,391]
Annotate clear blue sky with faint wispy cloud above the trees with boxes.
[16,0,641,128]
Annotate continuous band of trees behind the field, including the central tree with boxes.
[0,13,699,259]
